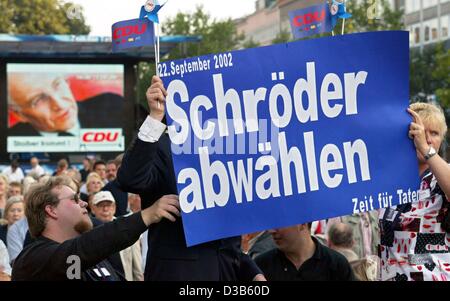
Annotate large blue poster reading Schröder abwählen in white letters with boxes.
[159,31,419,246]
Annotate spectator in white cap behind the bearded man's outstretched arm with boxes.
[92,191,144,281]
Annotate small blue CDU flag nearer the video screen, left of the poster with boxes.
[112,19,155,52]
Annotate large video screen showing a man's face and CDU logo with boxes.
[7,64,125,153]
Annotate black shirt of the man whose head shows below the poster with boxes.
[255,237,355,281]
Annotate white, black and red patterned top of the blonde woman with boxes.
[379,171,450,281]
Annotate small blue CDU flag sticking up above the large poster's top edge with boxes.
[289,3,333,39]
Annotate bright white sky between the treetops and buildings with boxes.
[68,0,255,36]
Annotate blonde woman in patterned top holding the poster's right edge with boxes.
[379,103,450,281]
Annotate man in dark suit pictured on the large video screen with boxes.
[8,73,123,136]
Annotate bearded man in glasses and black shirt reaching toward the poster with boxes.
[12,177,180,281]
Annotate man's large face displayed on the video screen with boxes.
[8,73,78,132]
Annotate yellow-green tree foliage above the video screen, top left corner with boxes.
[0,0,90,35]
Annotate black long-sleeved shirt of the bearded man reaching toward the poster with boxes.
[11,213,147,281]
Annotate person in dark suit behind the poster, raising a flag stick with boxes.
[118,76,265,281]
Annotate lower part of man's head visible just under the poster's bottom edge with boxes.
[269,224,311,253]
